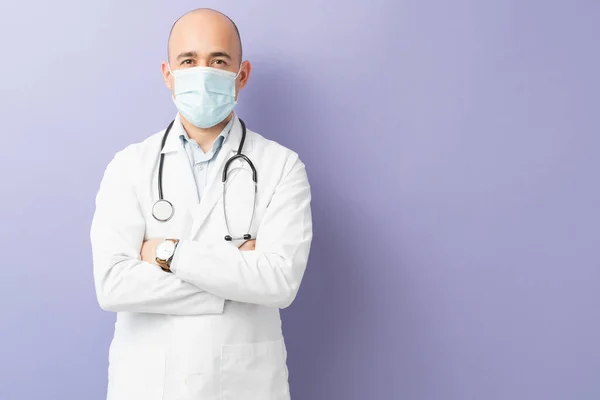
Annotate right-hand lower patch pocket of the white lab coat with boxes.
[220,339,290,400]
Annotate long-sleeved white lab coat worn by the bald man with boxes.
[90,116,312,400]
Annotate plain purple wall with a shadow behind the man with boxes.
[0,0,600,400]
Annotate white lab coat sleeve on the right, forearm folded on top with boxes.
[172,157,312,308]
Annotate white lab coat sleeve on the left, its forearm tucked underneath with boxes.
[90,148,224,315]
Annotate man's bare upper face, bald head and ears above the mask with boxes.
[162,11,251,99]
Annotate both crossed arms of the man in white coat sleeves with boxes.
[90,148,312,315]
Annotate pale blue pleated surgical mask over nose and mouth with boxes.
[168,65,242,128]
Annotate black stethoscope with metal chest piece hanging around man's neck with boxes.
[152,118,258,242]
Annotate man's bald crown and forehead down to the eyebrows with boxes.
[167,8,242,65]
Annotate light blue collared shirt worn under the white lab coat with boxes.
[171,117,235,273]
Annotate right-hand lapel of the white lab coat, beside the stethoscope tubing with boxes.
[190,114,251,238]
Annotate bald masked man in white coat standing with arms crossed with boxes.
[90,9,312,400]
